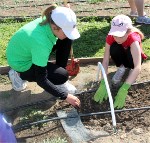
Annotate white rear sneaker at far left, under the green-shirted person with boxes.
[8,69,27,91]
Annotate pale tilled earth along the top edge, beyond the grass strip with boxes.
[0,0,150,18]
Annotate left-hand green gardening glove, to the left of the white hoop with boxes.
[94,80,108,103]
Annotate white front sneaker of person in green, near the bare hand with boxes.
[56,81,77,95]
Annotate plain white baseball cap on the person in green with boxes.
[51,6,80,40]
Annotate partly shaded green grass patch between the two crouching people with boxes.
[73,20,109,57]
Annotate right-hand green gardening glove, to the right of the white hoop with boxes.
[114,83,131,109]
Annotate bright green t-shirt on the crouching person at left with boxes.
[6,18,57,72]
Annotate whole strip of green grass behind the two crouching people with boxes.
[0,17,150,65]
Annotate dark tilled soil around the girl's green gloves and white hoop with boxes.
[80,83,150,131]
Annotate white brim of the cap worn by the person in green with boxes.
[63,28,80,40]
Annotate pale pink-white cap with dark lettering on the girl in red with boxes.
[108,14,133,37]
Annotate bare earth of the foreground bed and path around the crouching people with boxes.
[0,61,150,143]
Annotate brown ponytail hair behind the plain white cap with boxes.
[40,4,57,26]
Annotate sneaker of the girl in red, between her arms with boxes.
[112,65,125,85]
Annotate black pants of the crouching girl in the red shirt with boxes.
[110,42,142,69]
